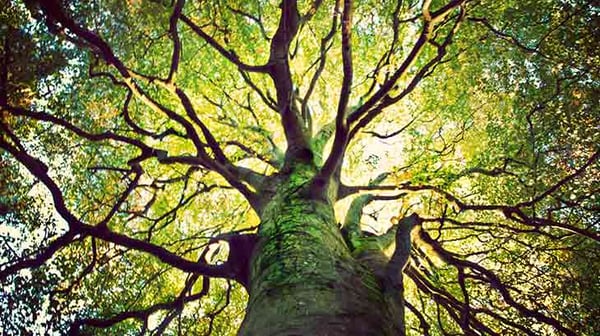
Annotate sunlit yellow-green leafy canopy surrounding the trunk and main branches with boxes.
[0,0,600,335]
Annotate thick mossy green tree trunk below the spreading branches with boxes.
[239,168,399,336]
